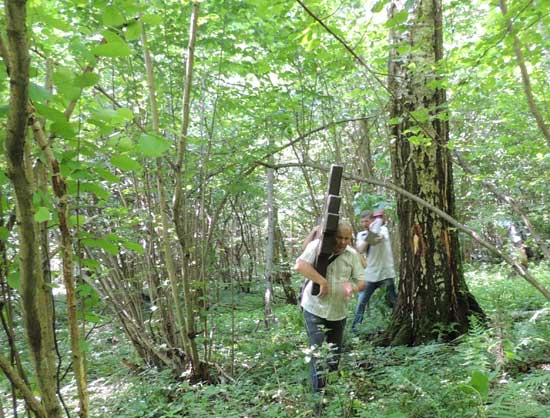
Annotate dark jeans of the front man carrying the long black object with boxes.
[304,310,346,392]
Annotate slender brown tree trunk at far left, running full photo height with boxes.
[5,0,61,418]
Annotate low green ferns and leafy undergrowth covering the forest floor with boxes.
[90,266,550,418]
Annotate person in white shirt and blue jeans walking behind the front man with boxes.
[351,209,397,333]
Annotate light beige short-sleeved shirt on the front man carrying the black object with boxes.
[298,239,364,321]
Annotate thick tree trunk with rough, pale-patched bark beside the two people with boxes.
[386,0,482,345]
